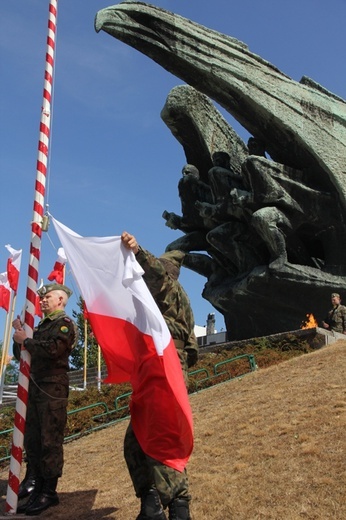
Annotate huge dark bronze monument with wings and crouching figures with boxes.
[95,1,346,339]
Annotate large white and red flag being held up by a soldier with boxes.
[52,218,193,471]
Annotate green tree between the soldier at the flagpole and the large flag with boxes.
[70,297,105,369]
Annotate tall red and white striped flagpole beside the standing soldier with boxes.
[5,0,58,514]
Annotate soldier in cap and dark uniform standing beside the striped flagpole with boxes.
[13,283,77,516]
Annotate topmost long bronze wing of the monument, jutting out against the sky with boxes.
[95,1,346,207]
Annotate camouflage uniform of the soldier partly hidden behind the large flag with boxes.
[124,248,198,507]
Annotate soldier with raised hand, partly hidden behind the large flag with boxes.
[121,232,198,520]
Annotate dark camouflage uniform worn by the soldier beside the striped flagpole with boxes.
[13,311,77,479]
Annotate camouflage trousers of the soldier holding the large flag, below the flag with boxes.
[124,423,190,507]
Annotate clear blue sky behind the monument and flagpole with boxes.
[0,0,346,339]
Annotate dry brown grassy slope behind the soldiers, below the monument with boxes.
[0,341,346,520]
